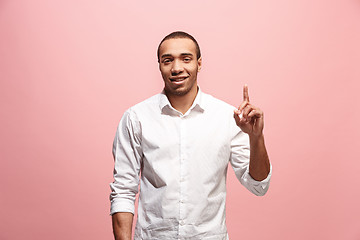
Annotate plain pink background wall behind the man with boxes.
[0,0,360,240]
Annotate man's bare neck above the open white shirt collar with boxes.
[165,85,198,114]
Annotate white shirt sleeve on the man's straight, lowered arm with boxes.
[110,110,142,215]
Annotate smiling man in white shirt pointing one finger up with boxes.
[110,32,271,240]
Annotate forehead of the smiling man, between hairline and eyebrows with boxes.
[159,38,196,57]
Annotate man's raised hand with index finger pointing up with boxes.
[234,84,264,137]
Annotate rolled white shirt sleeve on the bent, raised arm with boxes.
[230,121,272,196]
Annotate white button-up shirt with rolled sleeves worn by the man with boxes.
[110,89,272,240]
